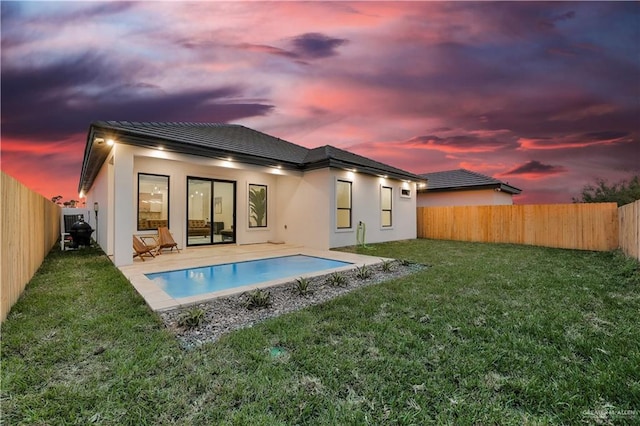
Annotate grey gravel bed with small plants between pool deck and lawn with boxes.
[159,260,426,349]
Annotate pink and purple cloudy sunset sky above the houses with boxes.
[1,1,640,204]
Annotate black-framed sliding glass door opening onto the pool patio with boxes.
[187,177,236,246]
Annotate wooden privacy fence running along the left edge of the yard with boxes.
[0,172,60,321]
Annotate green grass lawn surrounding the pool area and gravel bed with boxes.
[1,240,640,425]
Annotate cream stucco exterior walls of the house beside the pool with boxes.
[87,144,417,266]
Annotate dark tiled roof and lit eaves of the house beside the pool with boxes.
[78,121,424,192]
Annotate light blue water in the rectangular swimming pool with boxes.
[145,254,351,299]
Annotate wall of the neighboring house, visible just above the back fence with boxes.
[417,189,513,207]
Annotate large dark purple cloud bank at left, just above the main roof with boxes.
[1,54,273,140]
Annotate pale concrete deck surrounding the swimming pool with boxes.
[119,243,390,311]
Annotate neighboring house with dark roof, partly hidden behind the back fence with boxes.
[417,169,522,207]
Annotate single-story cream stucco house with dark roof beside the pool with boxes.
[78,121,424,266]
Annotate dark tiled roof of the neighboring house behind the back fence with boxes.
[420,169,522,194]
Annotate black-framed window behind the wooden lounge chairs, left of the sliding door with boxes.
[138,173,169,231]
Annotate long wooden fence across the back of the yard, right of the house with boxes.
[418,203,618,250]
